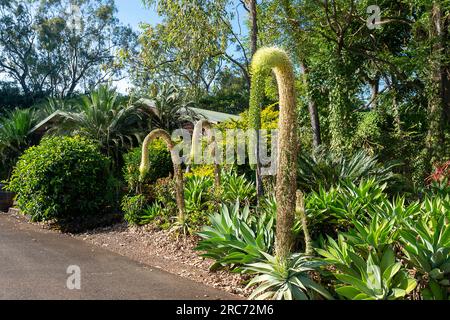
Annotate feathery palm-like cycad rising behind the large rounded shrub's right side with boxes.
[60,86,148,165]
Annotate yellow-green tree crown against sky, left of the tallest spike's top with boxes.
[128,0,250,98]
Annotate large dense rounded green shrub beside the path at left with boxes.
[8,137,111,221]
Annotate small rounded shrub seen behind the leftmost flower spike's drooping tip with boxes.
[123,139,173,190]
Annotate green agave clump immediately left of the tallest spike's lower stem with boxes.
[196,202,274,271]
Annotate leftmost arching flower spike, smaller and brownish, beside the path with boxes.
[139,129,186,231]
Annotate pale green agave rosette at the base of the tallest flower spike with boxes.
[245,253,333,300]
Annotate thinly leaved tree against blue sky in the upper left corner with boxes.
[0,0,135,97]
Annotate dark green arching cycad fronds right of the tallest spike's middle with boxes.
[297,148,398,191]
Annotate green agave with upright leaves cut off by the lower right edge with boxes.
[400,215,450,300]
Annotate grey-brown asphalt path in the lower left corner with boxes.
[0,213,236,300]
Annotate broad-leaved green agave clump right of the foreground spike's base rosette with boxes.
[316,230,417,300]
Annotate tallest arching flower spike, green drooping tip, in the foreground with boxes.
[250,48,298,258]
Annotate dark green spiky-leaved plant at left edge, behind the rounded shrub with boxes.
[0,109,37,179]
